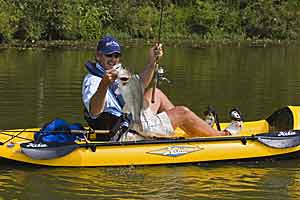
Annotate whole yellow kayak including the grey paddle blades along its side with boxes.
[0,106,300,167]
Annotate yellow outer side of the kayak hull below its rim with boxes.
[0,134,300,167]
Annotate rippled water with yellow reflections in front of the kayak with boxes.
[0,161,300,200]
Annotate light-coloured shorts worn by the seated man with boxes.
[141,107,174,136]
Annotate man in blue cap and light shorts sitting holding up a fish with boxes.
[82,36,234,139]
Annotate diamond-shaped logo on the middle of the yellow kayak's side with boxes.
[148,146,203,157]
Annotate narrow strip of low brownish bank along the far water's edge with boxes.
[0,39,300,50]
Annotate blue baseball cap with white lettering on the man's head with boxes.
[97,36,121,55]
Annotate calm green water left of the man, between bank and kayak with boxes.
[0,50,90,128]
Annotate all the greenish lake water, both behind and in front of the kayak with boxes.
[0,46,300,200]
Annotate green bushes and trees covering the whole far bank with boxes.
[0,0,300,50]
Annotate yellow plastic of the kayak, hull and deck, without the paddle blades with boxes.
[0,107,300,167]
